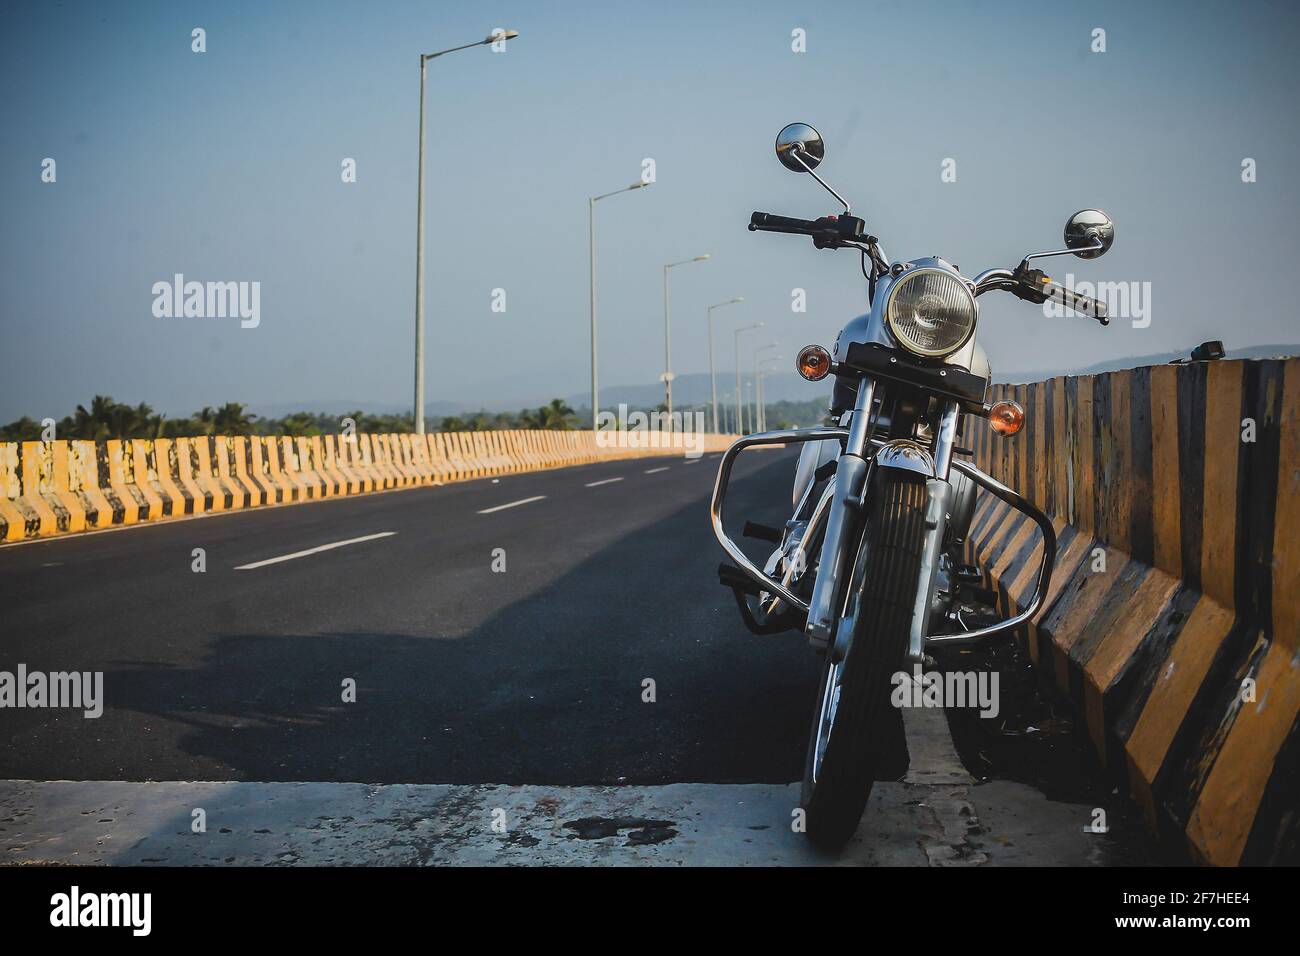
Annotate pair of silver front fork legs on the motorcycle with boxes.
[805,378,959,661]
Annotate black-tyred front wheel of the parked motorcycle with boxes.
[800,468,926,849]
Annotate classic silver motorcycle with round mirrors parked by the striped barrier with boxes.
[711,124,1114,848]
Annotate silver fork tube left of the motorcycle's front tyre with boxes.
[805,378,876,648]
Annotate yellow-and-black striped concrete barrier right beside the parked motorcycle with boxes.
[965,359,1300,865]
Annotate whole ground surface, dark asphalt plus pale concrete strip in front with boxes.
[0,451,1147,865]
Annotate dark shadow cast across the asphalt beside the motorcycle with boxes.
[0,453,816,786]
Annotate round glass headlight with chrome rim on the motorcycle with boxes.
[885,269,979,358]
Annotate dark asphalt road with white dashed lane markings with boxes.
[0,451,816,786]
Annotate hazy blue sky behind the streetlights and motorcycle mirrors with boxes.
[0,1,1300,421]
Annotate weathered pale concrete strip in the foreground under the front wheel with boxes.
[0,710,1131,866]
